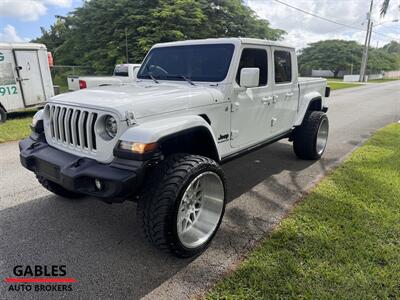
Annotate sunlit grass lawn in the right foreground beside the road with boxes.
[207,124,400,299]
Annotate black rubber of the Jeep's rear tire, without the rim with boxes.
[293,111,329,160]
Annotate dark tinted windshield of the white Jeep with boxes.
[138,44,234,82]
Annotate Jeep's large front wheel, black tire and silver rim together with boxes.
[138,154,226,257]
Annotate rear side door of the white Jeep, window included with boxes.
[270,47,299,136]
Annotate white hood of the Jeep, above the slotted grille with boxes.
[49,83,219,119]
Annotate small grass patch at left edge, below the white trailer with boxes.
[0,110,36,143]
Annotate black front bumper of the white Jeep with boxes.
[19,137,145,202]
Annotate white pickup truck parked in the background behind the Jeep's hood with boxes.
[67,64,140,91]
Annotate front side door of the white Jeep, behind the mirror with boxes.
[231,47,273,148]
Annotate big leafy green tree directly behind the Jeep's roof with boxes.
[35,0,285,74]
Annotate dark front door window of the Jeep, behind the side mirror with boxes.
[236,49,268,86]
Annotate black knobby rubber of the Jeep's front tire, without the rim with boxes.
[137,154,226,257]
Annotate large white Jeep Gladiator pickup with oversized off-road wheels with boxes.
[19,38,330,257]
